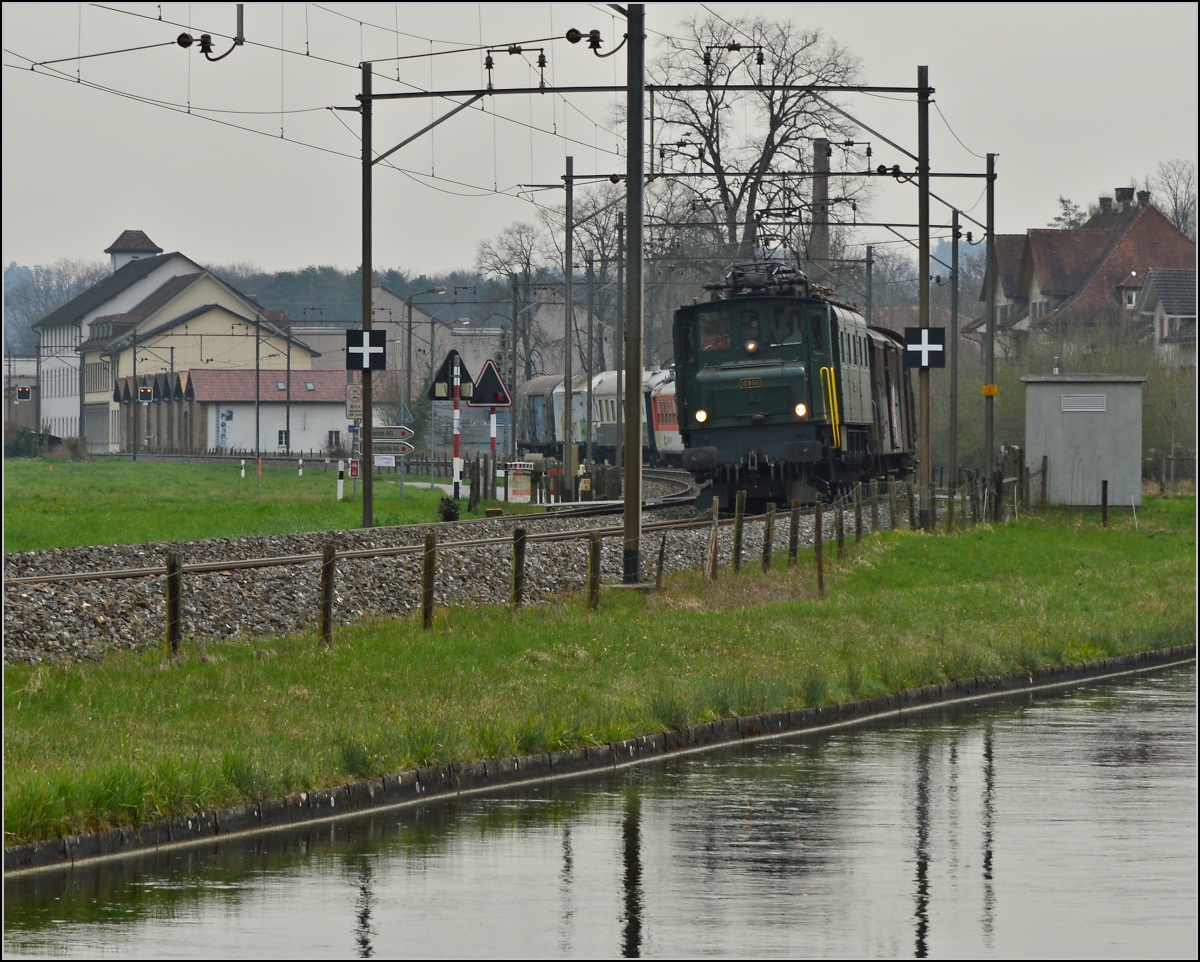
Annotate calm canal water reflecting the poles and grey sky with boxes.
[4,666,1198,958]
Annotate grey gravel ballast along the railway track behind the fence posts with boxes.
[4,494,904,663]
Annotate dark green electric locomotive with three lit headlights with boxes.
[674,261,916,509]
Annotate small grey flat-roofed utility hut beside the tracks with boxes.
[1021,374,1146,506]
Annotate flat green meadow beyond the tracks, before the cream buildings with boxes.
[4,458,529,551]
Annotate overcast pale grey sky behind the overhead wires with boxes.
[2,2,1198,272]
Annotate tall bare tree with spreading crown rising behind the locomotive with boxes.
[650,16,858,257]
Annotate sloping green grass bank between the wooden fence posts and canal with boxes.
[5,499,1195,843]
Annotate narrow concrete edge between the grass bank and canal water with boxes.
[4,643,1196,876]
